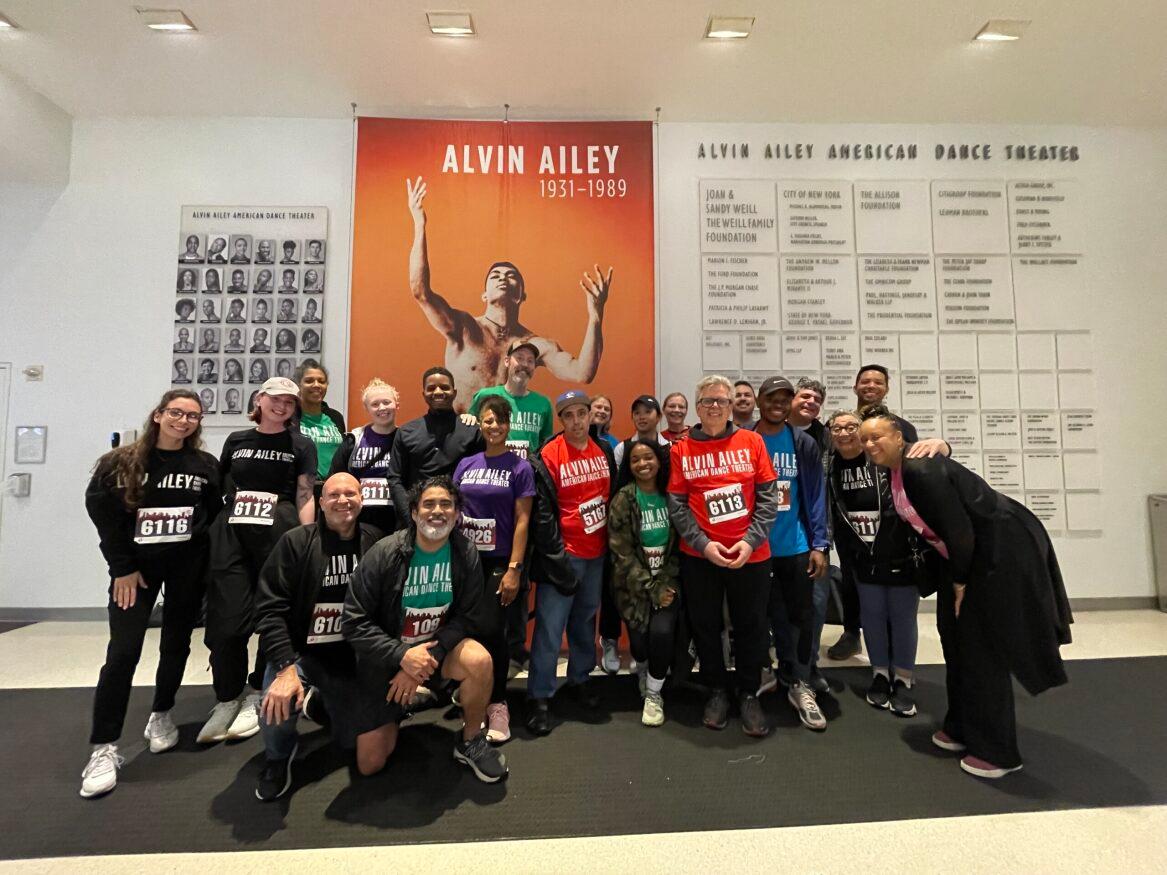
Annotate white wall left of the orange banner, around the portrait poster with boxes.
[0,119,352,608]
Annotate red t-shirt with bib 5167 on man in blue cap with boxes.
[540,435,612,559]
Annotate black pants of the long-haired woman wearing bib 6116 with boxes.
[89,548,207,744]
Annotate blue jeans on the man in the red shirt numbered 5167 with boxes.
[526,554,605,699]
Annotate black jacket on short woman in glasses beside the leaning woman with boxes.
[826,450,935,595]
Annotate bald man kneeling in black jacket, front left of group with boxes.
[256,474,397,802]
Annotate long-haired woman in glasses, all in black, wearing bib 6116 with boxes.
[81,389,223,798]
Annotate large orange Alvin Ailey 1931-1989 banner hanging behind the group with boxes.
[348,118,656,436]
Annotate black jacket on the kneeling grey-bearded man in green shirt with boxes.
[342,526,488,688]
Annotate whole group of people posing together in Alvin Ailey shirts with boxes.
[81,352,1071,800]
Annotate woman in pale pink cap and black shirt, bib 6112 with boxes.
[198,377,316,744]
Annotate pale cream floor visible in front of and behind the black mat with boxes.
[0,610,1167,873]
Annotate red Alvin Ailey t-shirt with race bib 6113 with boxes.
[669,428,777,562]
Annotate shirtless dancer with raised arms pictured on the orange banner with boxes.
[405,176,612,411]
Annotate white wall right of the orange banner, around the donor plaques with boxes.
[658,124,1167,599]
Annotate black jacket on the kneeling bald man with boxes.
[256,518,382,665]
